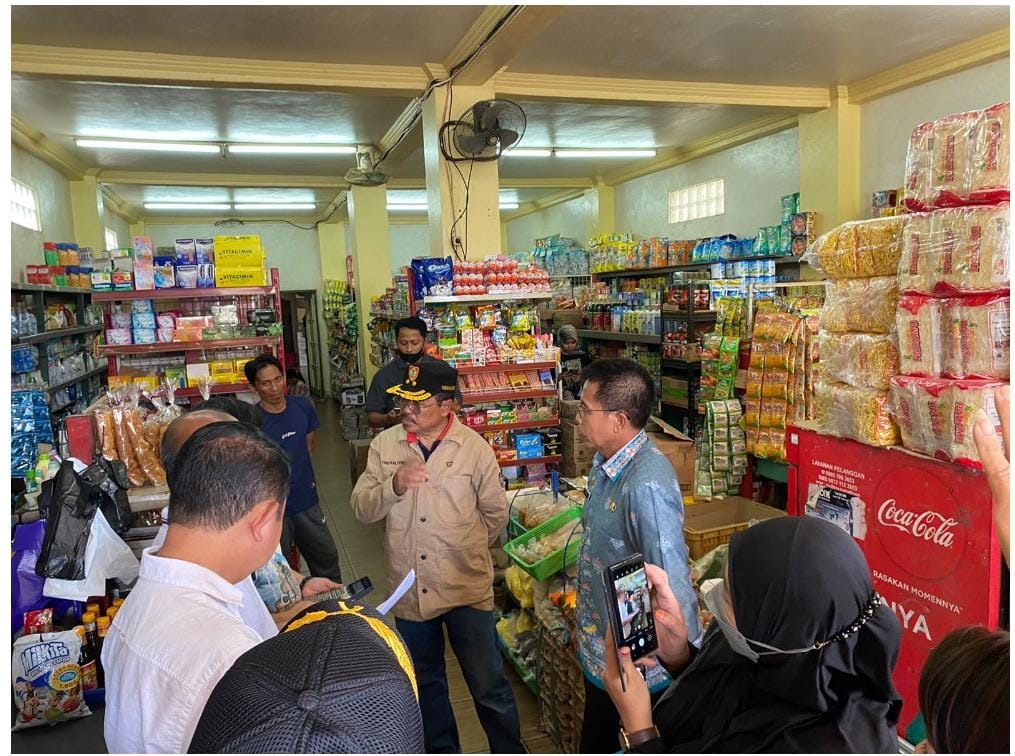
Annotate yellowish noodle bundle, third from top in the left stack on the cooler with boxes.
[818,331,899,391]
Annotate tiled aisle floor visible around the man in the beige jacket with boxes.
[314,401,558,753]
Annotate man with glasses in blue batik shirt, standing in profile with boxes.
[578,359,701,753]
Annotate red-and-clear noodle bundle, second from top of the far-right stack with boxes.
[898,202,1010,296]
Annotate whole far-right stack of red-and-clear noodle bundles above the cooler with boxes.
[891,102,1011,468]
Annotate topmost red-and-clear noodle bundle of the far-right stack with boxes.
[905,102,1011,211]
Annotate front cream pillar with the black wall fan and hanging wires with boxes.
[423,77,501,260]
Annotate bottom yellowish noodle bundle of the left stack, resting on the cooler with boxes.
[814,381,899,446]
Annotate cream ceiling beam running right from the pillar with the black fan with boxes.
[493,71,830,111]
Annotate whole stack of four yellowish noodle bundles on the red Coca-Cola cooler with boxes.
[804,216,905,446]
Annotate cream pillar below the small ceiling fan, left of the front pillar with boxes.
[353,187,391,386]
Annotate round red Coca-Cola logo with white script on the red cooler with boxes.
[870,465,970,580]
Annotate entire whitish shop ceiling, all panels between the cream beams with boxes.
[11,5,1009,217]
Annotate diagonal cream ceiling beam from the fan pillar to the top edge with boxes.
[444,5,566,86]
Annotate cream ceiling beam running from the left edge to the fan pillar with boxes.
[11,45,427,95]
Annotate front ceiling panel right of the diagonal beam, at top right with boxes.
[511,3,1009,86]
